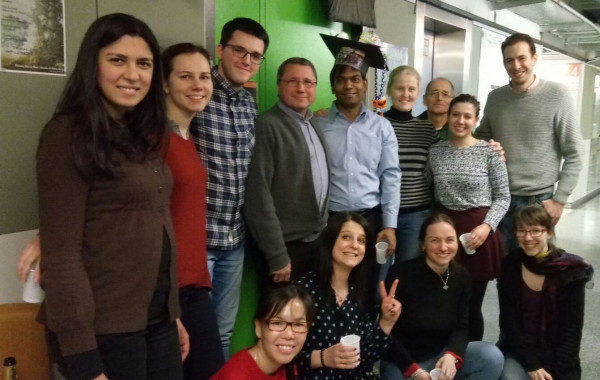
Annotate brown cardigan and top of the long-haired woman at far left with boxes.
[37,117,179,356]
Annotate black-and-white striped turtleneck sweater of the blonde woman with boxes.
[383,108,439,213]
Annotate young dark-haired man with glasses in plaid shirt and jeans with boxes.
[190,18,269,360]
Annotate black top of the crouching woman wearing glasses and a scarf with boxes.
[498,251,587,380]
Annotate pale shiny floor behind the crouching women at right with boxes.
[483,196,600,380]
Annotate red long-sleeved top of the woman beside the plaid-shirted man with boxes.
[167,132,211,288]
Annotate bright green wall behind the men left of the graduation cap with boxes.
[215,0,343,353]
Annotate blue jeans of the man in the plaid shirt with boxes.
[206,243,244,361]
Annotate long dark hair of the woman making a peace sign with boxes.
[318,212,375,311]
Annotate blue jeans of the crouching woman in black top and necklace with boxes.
[380,342,504,380]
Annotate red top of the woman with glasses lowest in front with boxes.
[210,349,286,380]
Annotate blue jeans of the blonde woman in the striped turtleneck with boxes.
[379,209,431,281]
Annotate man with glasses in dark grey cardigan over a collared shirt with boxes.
[244,57,329,282]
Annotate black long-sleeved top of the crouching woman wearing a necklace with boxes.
[384,255,471,372]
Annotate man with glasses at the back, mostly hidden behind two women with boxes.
[417,77,454,140]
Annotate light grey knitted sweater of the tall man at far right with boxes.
[475,79,583,204]
